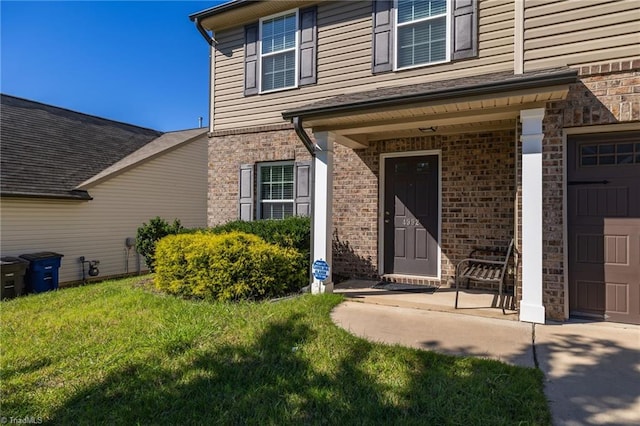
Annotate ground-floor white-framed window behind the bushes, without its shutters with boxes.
[258,162,295,219]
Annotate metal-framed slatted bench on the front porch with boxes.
[455,239,517,314]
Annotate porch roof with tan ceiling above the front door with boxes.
[283,68,576,148]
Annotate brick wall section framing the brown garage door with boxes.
[542,60,640,320]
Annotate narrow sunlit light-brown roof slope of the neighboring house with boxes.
[78,129,207,188]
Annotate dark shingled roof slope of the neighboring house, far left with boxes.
[0,94,162,200]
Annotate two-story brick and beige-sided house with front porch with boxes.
[190,0,640,323]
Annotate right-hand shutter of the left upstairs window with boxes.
[298,6,318,86]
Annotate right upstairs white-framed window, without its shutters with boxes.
[395,0,450,69]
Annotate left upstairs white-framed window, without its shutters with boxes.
[260,11,298,92]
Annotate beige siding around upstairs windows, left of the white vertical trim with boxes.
[214,0,514,130]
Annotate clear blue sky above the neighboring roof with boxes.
[0,0,222,131]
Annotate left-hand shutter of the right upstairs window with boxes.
[371,0,394,74]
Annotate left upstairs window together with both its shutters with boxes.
[244,6,317,96]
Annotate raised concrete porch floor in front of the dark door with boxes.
[334,280,518,321]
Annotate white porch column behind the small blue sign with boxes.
[311,132,333,294]
